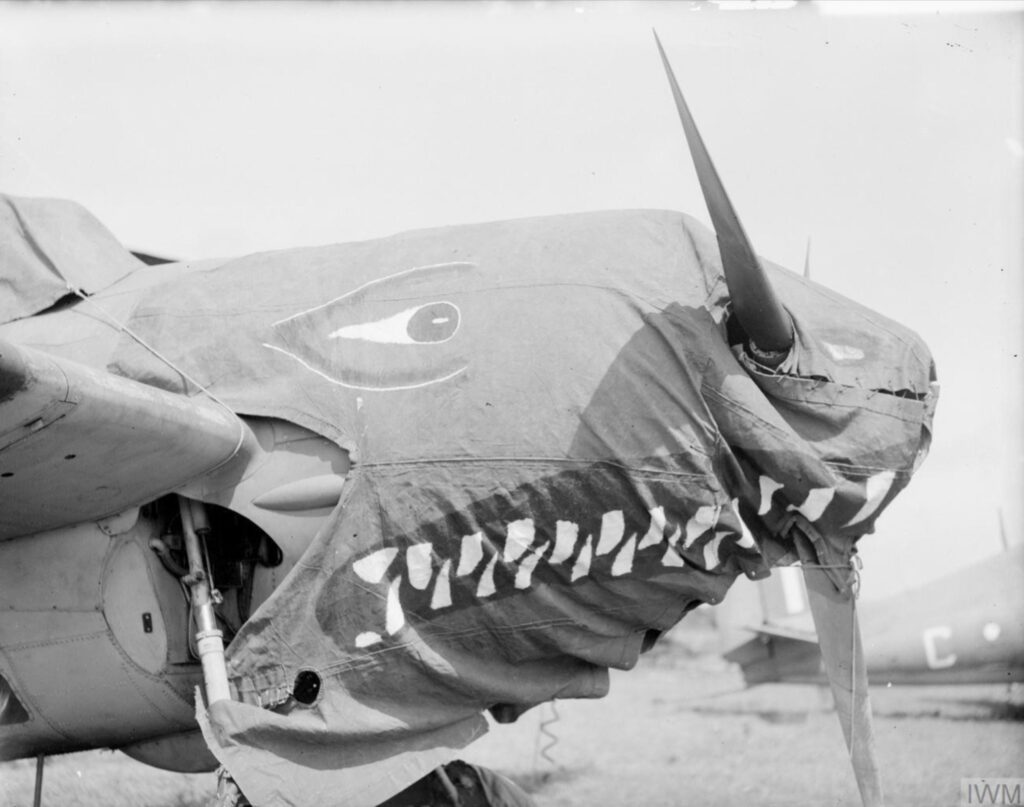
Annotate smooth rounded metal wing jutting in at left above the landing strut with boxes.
[0,341,245,540]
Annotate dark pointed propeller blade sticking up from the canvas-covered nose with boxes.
[654,31,793,360]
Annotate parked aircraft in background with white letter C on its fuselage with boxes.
[716,545,1024,685]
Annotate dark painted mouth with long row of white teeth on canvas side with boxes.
[316,463,761,650]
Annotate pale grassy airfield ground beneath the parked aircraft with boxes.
[0,642,1024,807]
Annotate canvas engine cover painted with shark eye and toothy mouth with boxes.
[105,211,936,804]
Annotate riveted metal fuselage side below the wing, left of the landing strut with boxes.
[0,509,209,770]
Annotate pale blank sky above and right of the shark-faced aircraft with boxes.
[0,2,1024,598]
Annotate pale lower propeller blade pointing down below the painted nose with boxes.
[801,552,884,807]
